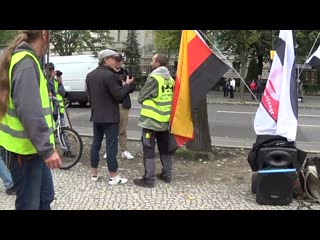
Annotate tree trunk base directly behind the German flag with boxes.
[187,97,212,152]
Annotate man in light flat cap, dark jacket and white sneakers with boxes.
[86,49,134,185]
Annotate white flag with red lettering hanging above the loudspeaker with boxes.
[254,30,298,141]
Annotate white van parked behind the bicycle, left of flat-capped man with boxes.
[49,55,98,106]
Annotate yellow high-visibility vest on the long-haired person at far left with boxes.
[0,51,55,155]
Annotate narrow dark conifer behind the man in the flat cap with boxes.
[124,30,141,78]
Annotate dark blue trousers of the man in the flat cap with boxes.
[90,123,119,172]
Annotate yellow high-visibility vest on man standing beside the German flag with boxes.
[140,74,175,122]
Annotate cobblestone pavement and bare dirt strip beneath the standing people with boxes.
[0,138,320,210]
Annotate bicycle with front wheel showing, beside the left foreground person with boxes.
[51,96,83,170]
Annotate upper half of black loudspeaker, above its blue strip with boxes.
[256,147,300,170]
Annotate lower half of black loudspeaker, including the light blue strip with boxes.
[255,168,297,205]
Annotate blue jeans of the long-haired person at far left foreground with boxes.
[9,152,54,210]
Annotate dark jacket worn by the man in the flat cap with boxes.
[86,66,133,123]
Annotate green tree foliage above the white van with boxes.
[51,30,113,56]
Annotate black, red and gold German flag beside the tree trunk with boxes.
[169,30,229,151]
